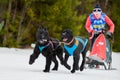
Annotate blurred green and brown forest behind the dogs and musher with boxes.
[0,0,120,52]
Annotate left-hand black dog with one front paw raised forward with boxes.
[29,28,63,72]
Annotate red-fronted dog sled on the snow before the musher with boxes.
[86,33,112,70]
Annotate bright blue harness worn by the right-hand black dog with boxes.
[64,37,88,56]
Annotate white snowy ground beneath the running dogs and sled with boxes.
[0,48,120,80]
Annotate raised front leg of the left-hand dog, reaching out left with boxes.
[29,45,40,64]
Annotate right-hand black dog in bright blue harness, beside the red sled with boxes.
[61,30,88,73]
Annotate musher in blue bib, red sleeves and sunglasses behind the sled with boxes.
[85,4,115,68]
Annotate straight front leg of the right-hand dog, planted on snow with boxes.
[71,53,80,73]
